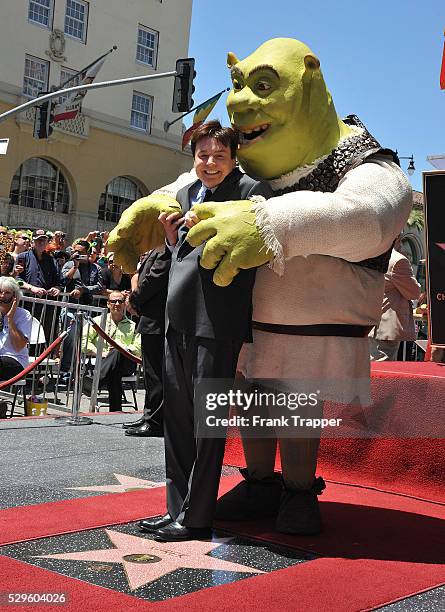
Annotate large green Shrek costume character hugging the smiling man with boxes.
[108,38,412,534]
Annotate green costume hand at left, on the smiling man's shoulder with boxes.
[107,194,181,274]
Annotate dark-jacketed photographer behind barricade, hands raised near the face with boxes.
[60,240,102,383]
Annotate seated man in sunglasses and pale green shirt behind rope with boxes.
[83,291,141,412]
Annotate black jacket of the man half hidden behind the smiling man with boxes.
[129,249,171,335]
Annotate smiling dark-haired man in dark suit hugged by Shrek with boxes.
[139,121,272,541]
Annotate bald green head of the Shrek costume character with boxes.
[227,38,348,179]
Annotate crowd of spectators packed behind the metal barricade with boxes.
[0,226,140,406]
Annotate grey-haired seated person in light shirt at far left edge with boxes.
[0,276,32,418]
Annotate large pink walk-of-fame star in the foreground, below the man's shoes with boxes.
[36,529,264,591]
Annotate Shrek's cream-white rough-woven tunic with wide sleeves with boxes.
[157,151,412,403]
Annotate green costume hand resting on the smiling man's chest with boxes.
[187,200,273,287]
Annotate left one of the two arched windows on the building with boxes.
[9,157,70,214]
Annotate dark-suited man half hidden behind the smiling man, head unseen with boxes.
[123,248,171,437]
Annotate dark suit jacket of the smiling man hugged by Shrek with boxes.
[167,168,272,341]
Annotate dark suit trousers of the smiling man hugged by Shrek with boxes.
[164,327,242,528]
